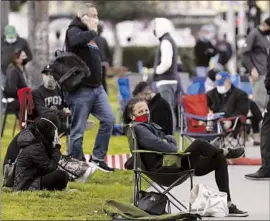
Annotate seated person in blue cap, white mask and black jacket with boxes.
[207,71,249,129]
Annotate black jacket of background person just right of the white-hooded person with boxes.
[194,39,217,67]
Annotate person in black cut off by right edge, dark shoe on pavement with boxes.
[245,50,270,180]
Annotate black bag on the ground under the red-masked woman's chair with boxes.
[138,191,168,215]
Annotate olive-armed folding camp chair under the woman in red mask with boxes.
[126,123,194,213]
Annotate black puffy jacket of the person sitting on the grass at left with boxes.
[13,127,61,191]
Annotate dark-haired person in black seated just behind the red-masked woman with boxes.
[132,81,173,135]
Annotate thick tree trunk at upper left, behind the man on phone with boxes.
[27,1,49,87]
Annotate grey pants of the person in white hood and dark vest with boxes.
[157,83,177,132]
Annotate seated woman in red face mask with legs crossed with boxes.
[123,98,248,216]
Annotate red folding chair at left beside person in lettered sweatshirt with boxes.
[17,87,34,130]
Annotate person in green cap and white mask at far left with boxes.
[1,25,33,75]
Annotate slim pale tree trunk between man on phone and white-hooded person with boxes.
[112,23,123,67]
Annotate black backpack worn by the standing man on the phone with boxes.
[52,50,91,92]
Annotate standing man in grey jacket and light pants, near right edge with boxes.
[242,17,270,111]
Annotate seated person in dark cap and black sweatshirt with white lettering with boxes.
[32,64,69,133]
